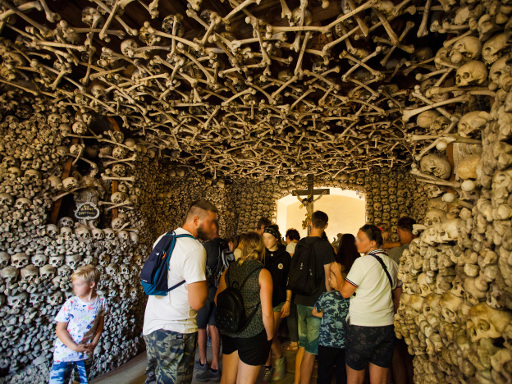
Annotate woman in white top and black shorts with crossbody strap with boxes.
[331,224,401,384]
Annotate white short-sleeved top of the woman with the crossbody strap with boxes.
[346,254,399,327]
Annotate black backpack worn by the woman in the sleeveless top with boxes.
[215,266,263,333]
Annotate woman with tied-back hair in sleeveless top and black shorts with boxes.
[215,232,274,384]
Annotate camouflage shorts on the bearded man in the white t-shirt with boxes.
[144,329,197,384]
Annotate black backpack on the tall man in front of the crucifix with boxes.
[288,238,321,296]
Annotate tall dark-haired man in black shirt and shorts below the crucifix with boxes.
[295,211,335,384]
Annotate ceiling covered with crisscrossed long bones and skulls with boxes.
[0,0,463,177]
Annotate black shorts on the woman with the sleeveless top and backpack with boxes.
[222,330,272,366]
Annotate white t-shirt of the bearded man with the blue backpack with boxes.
[142,228,206,335]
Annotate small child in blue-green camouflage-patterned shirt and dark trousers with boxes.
[313,264,349,384]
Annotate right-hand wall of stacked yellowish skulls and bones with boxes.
[395,2,512,384]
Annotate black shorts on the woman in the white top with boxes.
[345,324,396,371]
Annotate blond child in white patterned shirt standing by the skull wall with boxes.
[50,265,107,384]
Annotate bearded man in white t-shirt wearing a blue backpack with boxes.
[141,200,218,384]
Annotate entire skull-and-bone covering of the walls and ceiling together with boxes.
[0,0,512,384]
